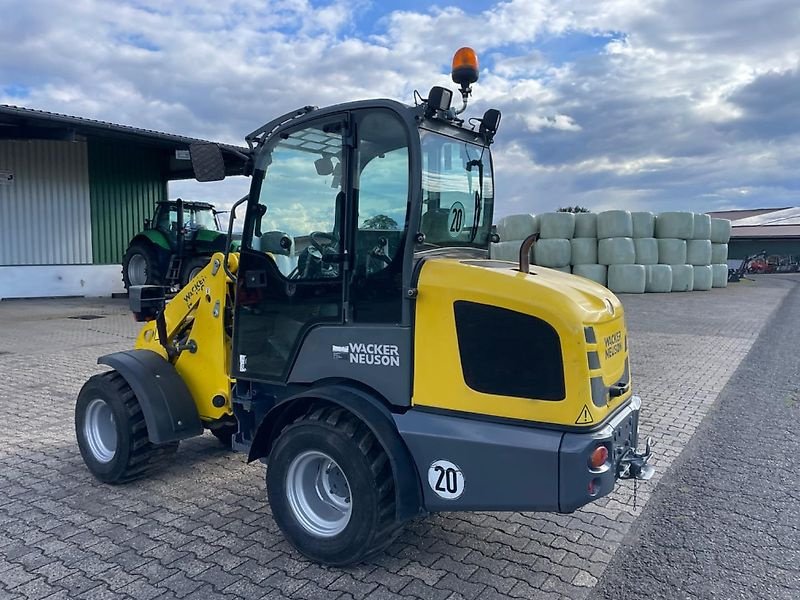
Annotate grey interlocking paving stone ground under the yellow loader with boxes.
[0,277,788,600]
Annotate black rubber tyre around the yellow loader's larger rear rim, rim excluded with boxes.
[267,405,402,566]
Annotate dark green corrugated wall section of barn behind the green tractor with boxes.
[89,140,167,265]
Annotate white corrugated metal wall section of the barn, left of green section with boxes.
[0,140,92,266]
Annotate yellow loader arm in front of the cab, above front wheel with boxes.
[136,253,239,422]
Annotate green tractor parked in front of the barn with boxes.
[122,198,231,290]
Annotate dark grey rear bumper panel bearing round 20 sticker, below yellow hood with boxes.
[394,396,641,512]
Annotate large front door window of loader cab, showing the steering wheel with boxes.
[252,119,344,279]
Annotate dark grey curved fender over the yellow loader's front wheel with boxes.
[97,350,203,444]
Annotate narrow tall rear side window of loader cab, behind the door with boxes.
[352,110,409,323]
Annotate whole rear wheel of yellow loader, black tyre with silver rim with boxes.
[267,405,401,566]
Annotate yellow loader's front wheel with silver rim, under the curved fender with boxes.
[75,371,178,483]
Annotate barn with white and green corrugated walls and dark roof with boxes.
[0,105,244,299]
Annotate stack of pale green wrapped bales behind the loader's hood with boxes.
[491,210,731,294]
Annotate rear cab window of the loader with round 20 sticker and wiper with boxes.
[417,130,494,250]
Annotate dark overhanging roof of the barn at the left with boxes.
[0,104,247,179]
